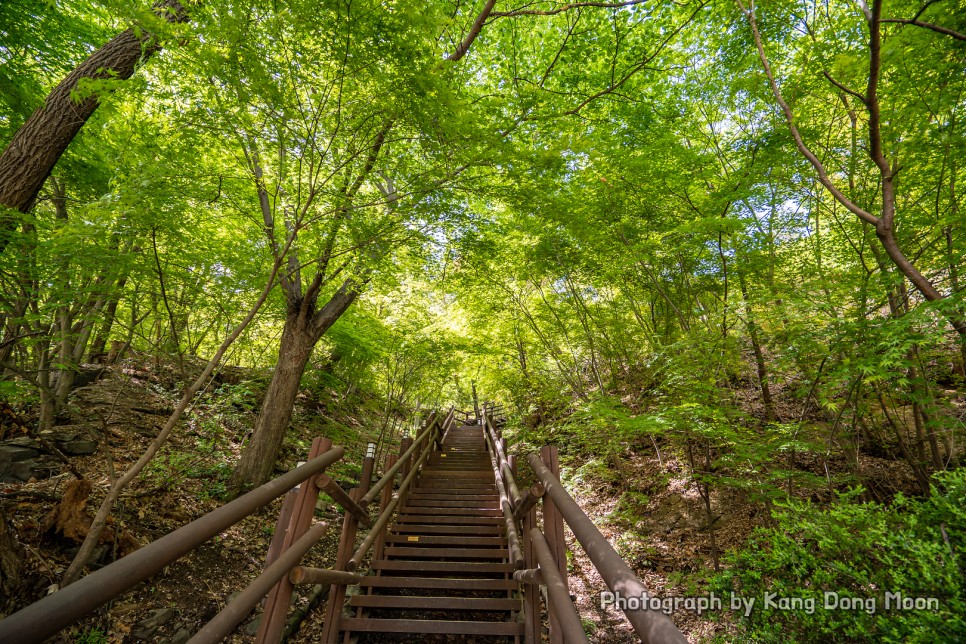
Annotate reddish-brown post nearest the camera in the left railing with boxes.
[255,438,332,644]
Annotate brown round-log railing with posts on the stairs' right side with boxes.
[481,403,687,644]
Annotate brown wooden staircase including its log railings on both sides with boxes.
[0,403,687,644]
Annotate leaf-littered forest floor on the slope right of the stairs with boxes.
[536,372,966,644]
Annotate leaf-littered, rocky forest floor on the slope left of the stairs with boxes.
[0,360,390,644]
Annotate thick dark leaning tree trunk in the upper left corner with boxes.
[0,0,187,251]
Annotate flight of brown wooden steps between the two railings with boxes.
[341,425,524,642]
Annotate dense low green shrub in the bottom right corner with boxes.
[711,469,966,642]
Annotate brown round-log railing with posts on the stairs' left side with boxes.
[0,409,454,644]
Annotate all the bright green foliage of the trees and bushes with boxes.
[0,0,966,638]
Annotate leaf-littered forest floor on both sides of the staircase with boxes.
[0,360,952,644]
